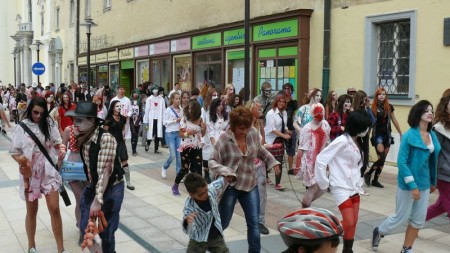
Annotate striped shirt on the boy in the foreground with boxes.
[183,177,227,242]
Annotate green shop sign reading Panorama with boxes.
[253,19,298,41]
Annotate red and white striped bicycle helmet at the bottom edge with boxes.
[278,208,343,247]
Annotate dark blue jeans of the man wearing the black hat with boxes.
[80,181,124,253]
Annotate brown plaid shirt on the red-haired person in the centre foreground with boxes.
[208,127,280,192]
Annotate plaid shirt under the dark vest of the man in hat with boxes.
[83,127,117,203]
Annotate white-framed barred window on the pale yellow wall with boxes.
[364,11,416,105]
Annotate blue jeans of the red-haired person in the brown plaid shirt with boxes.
[219,185,261,253]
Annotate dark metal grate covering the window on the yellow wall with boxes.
[377,20,410,96]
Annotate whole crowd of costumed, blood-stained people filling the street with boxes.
[0,79,450,253]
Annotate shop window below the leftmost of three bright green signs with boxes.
[195,52,224,91]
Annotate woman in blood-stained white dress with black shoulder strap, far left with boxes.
[9,97,66,253]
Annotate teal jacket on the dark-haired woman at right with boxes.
[397,128,441,190]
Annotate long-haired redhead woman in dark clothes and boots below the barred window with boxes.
[364,88,402,188]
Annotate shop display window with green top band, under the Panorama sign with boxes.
[257,46,298,97]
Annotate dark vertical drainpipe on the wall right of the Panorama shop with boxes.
[322,0,331,101]
